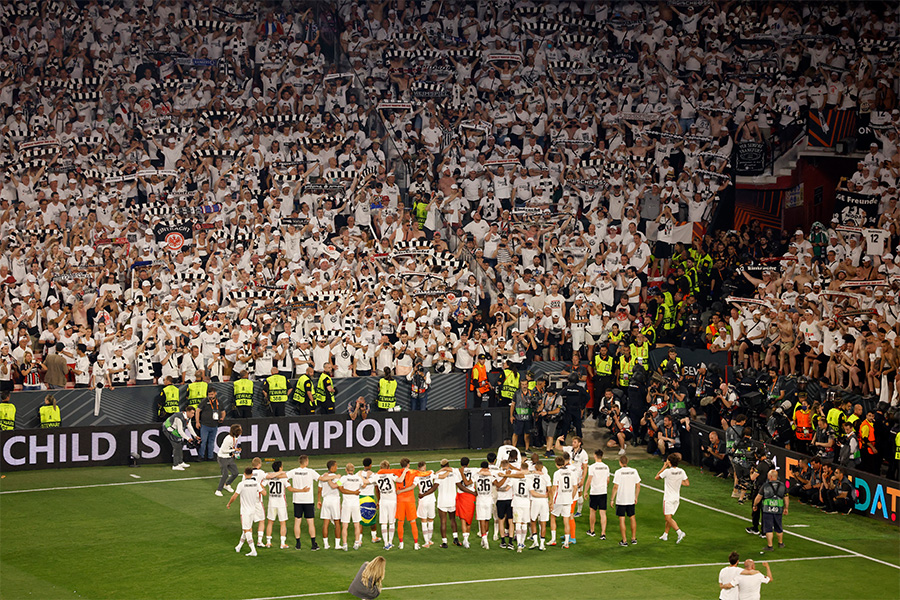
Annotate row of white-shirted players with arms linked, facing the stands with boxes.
[225,437,688,556]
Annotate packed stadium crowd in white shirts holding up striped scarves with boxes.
[0,0,900,482]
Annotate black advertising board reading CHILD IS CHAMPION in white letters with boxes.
[0,410,469,472]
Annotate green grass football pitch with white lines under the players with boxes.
[0,448,900,600]
